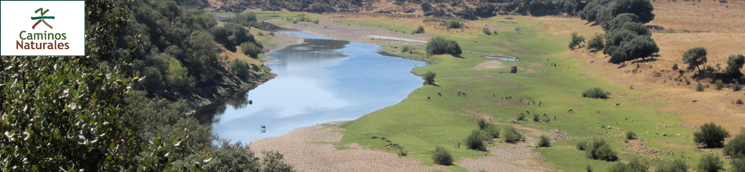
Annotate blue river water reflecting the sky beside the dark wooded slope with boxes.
[197,31,426,143]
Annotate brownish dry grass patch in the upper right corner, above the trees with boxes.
[649,0,745,32]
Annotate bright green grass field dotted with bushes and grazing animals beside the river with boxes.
[240,12,729,171]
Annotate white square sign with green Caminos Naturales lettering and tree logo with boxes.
[0,0,85,56]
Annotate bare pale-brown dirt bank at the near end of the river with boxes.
[249,122,447,172]
